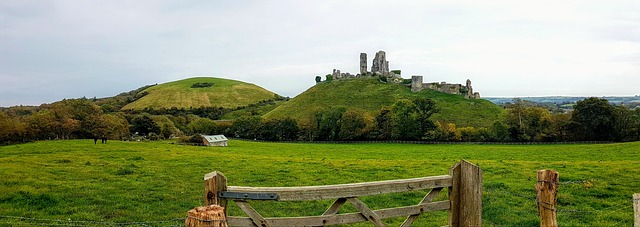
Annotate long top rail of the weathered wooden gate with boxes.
[227,175,452,201]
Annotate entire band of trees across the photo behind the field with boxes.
[0,98,640,144]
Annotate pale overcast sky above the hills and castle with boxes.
[0,0,640,106]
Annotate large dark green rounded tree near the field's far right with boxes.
[571,97,615,141]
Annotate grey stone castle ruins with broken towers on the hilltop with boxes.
[316,50,480,99]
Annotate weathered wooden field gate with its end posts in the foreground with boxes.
[204,160,482,226]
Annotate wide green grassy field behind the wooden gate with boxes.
[0,140,640,226]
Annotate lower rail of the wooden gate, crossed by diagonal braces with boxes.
[227,201,450,226]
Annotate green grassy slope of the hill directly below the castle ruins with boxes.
[265,78,503,127]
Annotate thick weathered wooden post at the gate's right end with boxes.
[449,160,482,227]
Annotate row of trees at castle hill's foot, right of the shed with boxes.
[215,98,640,142]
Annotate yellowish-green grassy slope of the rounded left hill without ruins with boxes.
[122,77,275,110]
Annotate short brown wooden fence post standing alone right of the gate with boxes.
[536,170,559,227]
